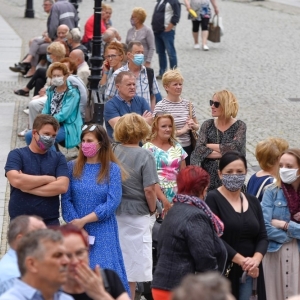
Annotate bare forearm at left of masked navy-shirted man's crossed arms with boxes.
[6,170,56,190]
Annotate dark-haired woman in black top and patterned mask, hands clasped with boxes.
[206,151,268,300]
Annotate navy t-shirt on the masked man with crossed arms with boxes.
[5,147,68,223]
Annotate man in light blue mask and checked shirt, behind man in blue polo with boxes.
[105,41,161,111]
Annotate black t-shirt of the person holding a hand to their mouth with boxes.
[65,269,126,300]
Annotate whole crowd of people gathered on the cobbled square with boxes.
[0,0,300,300]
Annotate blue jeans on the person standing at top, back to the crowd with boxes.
[154,30,177,75]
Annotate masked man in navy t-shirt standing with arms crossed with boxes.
[5,115,69,225]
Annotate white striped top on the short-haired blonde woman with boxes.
[153,98,196,147]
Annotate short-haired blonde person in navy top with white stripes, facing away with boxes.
[247,138,289,201]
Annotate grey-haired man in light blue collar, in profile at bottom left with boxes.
[0,229,73,300]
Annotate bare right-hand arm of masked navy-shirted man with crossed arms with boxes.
[22,176,69,197]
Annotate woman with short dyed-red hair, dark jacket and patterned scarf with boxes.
[152,166,227,300]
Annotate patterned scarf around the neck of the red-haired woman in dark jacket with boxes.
[173,194,224,237]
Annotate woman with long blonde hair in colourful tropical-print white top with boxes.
[143,114,187,212]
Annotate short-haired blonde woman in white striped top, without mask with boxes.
[153,69,200,165]
